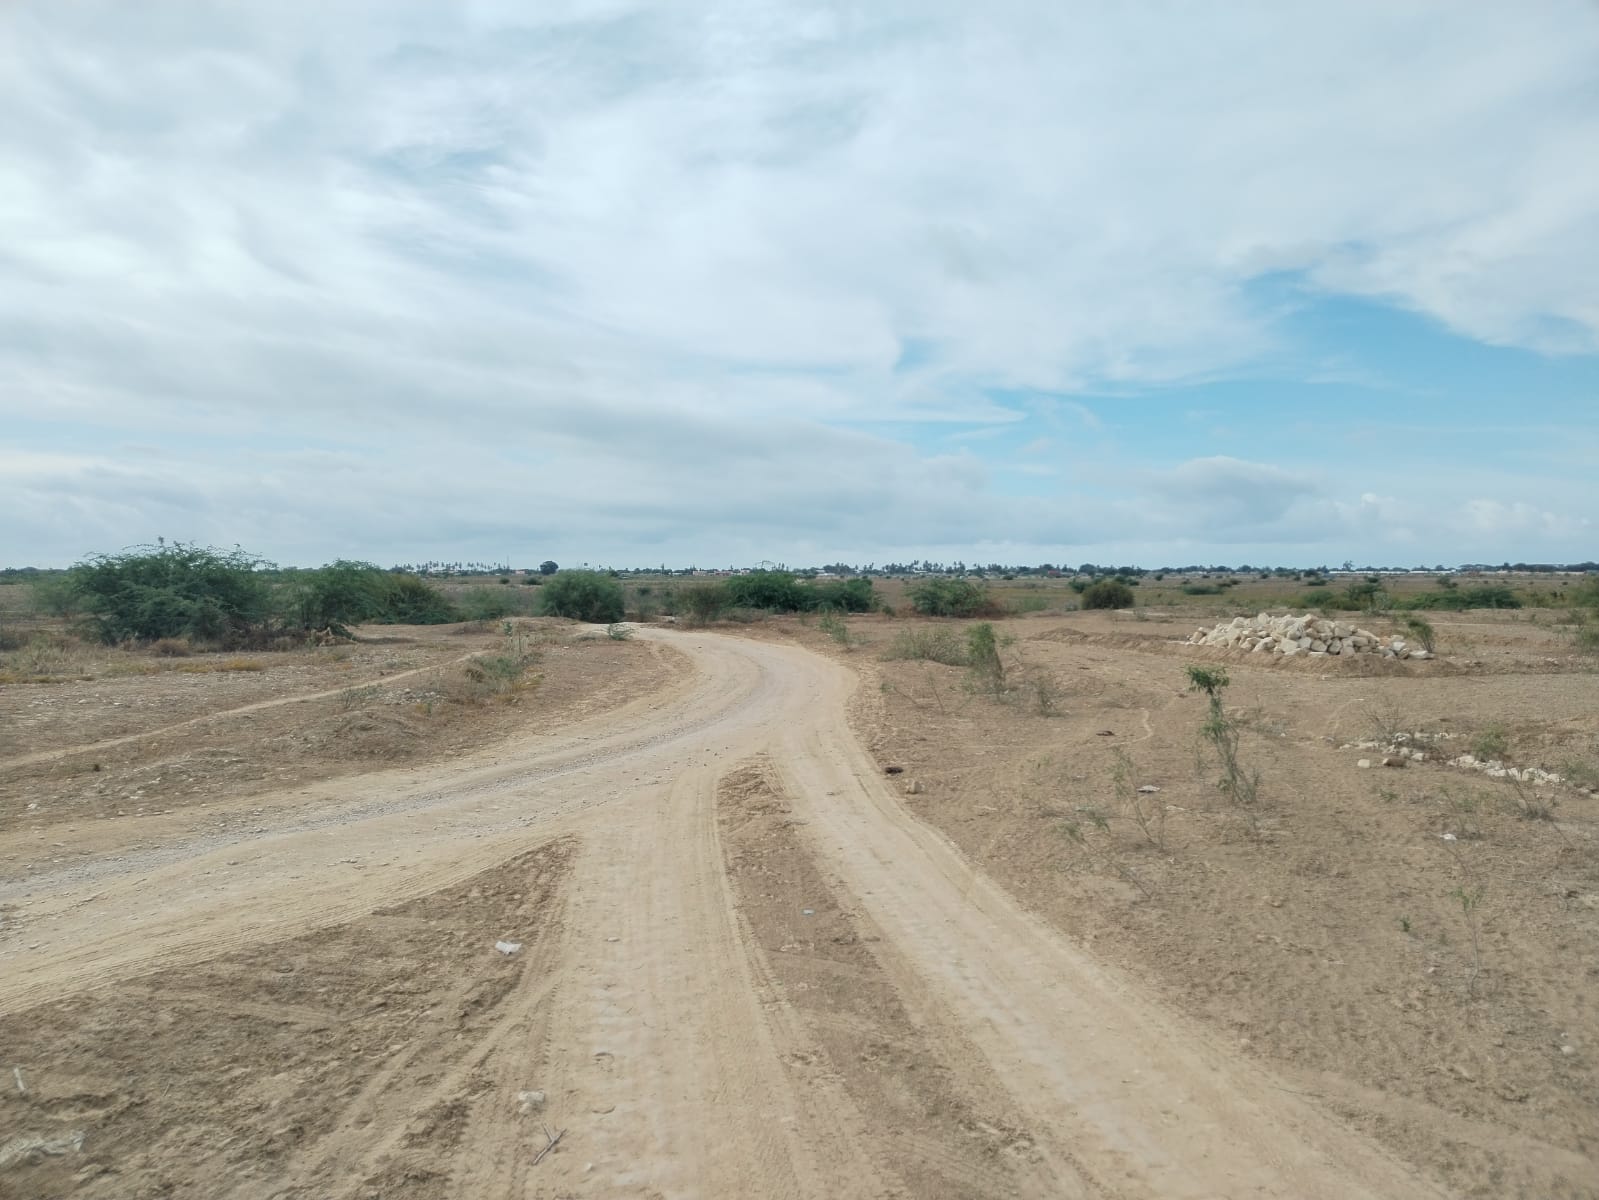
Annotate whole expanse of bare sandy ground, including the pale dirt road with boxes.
[0,619,1599,1198]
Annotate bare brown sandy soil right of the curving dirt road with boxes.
[851,614,1599,1197]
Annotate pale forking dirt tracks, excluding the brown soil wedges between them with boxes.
[0,632,1436,1197]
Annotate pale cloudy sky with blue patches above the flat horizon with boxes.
[0,0,1599,566]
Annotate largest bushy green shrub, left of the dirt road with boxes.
[70,542,272,645]
